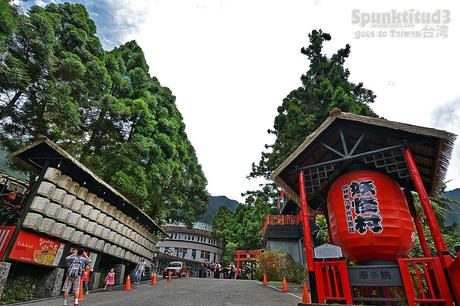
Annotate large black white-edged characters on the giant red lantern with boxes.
[342,180,383,235]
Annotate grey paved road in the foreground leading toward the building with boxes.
[20,278,300,306]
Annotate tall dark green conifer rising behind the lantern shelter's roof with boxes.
[249,30,375,179]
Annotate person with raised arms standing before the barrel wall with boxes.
[62,248,92,306]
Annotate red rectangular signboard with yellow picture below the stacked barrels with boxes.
[9,231,65,267]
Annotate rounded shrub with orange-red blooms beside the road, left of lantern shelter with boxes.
[257,250,306,284]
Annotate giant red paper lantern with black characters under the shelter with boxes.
[327,170,415,263]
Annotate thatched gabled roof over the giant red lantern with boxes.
[272,111,456,203]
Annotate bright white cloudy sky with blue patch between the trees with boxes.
[18,0,460,200]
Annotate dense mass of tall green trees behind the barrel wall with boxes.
[0,0,207,224]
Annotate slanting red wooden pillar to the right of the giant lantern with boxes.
[402,147,448,268]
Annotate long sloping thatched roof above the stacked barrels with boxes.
[11,137,166,234]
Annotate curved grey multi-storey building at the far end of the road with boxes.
[156,222,222,263]
